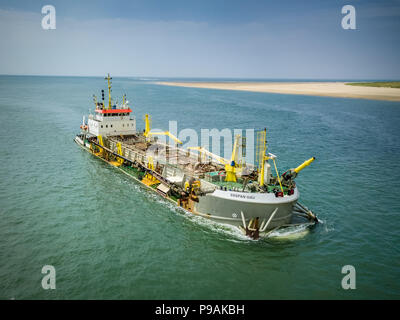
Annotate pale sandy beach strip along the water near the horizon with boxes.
[157,82,400,101]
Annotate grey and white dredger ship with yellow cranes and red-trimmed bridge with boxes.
[75,74,318,239]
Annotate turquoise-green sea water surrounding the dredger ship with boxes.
[0,76,400,299]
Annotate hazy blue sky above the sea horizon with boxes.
[0,0,400,79]
